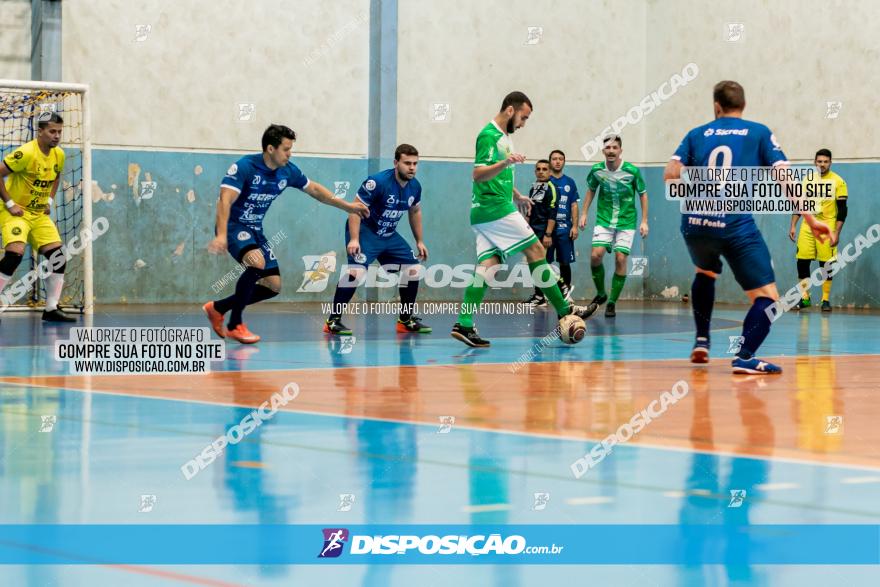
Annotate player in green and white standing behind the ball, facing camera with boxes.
[579,135,648,318]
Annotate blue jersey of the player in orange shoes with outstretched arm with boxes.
[220,153,309,231]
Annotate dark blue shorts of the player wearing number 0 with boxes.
[684,228,776,291]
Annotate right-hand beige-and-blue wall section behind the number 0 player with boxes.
[642,0,880,307]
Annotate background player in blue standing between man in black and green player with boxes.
[547,149,580,301]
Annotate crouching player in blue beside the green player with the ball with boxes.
[324,144,431,335]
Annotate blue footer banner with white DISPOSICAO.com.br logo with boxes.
[0,524,880,565]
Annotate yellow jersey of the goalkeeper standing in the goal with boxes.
[3,139,65,212]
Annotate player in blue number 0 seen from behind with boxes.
[663,81,830,374]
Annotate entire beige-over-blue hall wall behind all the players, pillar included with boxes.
[41,0,880,307]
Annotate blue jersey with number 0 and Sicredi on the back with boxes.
[672,117,787,236]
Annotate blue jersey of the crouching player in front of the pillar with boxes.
[357,168,422,238]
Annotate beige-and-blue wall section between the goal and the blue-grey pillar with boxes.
[57,0,369,303]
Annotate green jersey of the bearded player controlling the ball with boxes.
[471,120,516,224]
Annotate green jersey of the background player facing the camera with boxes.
[587,161,646,230]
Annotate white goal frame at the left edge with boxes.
[0,79,95,315]
